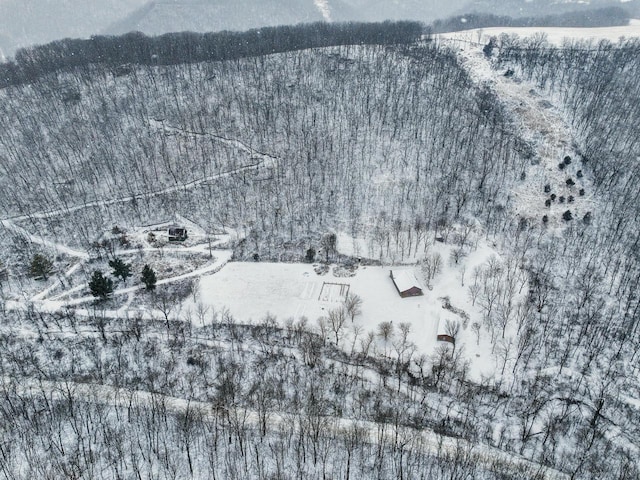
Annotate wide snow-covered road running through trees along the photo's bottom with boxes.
[0,377,569,480]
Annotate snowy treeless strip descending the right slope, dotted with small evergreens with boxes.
[444,33,596,226]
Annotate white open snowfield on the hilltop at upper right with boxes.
[438,19,640,45]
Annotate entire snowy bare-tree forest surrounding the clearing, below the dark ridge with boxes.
[0,25,640,479]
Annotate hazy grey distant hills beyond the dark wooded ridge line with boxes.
[0,0,640,60]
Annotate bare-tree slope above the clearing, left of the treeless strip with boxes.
[0,30,520,255]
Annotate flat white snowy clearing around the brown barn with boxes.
[195,238,510,379]
